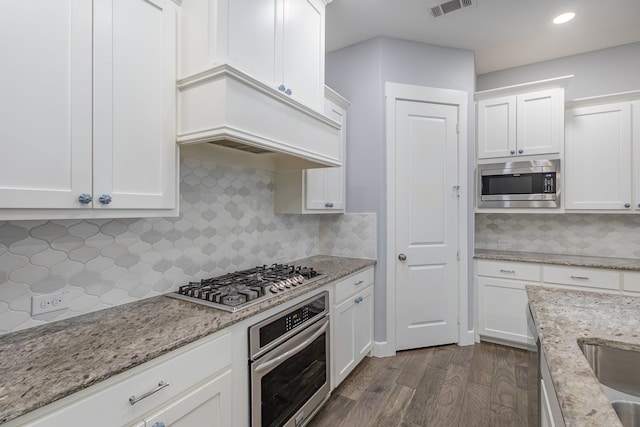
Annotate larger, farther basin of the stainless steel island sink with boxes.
[578,342,640,397]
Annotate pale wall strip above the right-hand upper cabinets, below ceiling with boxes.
[477,41,640,100]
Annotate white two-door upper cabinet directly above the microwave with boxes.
[476,78,566,160]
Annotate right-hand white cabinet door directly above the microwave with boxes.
[516,88,564,156]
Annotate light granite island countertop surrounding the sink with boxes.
[527,286,640,427]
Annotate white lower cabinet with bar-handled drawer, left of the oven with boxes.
[7,333,233,427]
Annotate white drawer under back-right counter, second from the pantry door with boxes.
[543,265,620,290]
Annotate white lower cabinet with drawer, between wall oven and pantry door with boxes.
[332,268,374,388]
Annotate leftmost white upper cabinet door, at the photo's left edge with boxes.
[0,0,92,208]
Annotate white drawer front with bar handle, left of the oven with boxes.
[21,334,232,427]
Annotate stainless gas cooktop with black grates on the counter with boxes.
[168,264,324,312]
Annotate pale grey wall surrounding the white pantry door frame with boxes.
[326,37,475,341]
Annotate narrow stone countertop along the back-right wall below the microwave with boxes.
[474,249,640,271]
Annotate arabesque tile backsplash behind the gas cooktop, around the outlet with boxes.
[0,158,376,333]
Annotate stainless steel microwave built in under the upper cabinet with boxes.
[478,159,561,208]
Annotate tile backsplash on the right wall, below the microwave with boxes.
[475,213,640,258]
